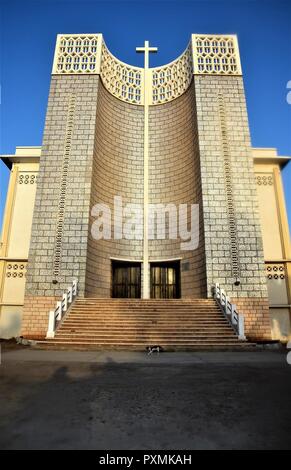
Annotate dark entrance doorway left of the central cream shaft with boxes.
[112,261,141,299]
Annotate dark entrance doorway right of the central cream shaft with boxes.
[151,261,180,299]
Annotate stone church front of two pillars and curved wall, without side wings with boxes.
[22,34,270,339]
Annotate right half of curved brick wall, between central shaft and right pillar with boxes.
[149,83,206,297]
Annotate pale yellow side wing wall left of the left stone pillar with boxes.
[0,149,40,338]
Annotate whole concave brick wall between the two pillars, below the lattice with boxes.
[86,81,206,297]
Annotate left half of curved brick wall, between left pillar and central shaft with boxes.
[86,80,144,297]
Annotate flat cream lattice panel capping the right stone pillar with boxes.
[192,34,242,75]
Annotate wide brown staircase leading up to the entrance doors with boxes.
[37,298,253,351]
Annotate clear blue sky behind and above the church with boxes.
[0,0,291,234]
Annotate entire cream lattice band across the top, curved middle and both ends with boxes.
[52,34,242,105]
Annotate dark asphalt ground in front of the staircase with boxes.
[0,349,291,450]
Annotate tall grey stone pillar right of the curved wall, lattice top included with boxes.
[192,35,271,339]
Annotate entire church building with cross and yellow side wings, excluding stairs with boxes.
[0,34,291,341]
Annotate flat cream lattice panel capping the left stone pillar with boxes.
[52,34,102,74]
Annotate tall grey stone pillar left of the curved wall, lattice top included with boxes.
[22,35,101,337]
